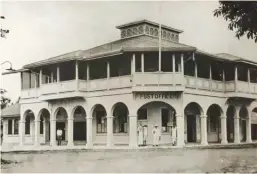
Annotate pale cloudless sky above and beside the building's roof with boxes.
[0,0,257,102]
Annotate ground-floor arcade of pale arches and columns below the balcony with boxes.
[14,96,257,147]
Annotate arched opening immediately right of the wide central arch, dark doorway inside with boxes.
[184,102,203,143]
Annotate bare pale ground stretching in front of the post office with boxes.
[1,148,257,173]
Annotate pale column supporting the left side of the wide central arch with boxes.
[129,114,138,148]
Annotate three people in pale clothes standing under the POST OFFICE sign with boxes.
[137,122,177,146]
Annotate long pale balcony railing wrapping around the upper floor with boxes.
[21,72,257,99]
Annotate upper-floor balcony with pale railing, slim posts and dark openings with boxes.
[21,52,257,100]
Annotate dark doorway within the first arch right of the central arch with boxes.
[187,115,196,142]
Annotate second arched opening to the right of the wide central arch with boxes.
[207,104,222,143]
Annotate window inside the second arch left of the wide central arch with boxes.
[96,111,107,133]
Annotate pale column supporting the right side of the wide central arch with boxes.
[176,115,185,147]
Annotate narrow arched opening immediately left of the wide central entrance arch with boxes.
[113,103,129,133]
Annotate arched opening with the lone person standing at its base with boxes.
[56,107,68,142]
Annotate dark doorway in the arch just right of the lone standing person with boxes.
[73,122,87,141]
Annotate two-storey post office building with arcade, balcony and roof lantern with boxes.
[2,20,257,148]
